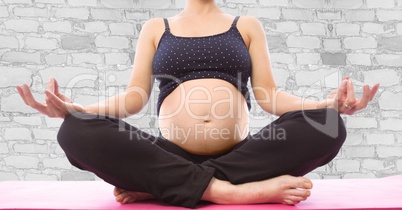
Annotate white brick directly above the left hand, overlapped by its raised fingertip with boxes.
[39,66,98,88]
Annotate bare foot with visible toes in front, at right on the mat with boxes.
[202,175,313,205]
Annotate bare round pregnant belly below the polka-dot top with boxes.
[159,79,249,155]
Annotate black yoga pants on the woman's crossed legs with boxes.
[57,109,346,208]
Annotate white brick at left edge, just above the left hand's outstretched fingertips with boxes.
[0,66,32,88]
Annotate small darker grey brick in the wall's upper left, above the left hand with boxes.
[61,34,94,50]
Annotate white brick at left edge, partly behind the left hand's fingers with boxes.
[0,93,44,114]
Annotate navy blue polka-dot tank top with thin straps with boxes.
[153,17,251,116]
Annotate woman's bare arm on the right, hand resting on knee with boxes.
[239,17,379,115]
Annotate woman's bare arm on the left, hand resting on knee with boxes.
[17,19,163,118]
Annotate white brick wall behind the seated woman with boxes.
[0,0,402,181]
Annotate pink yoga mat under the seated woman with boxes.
[0,176,402,210]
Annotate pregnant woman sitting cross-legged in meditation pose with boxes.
[17,0,378,208]
